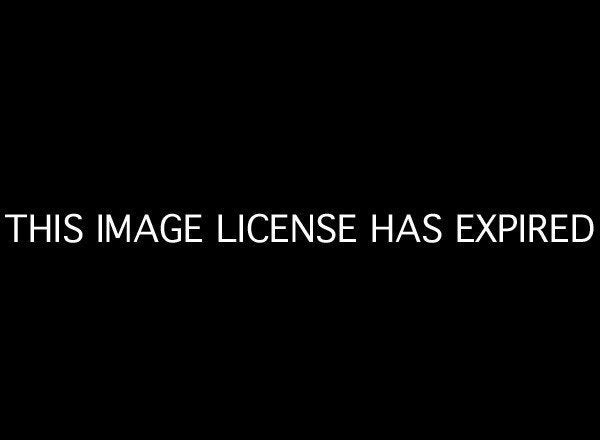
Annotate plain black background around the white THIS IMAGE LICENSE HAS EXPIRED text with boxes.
[1,5,598,433]
